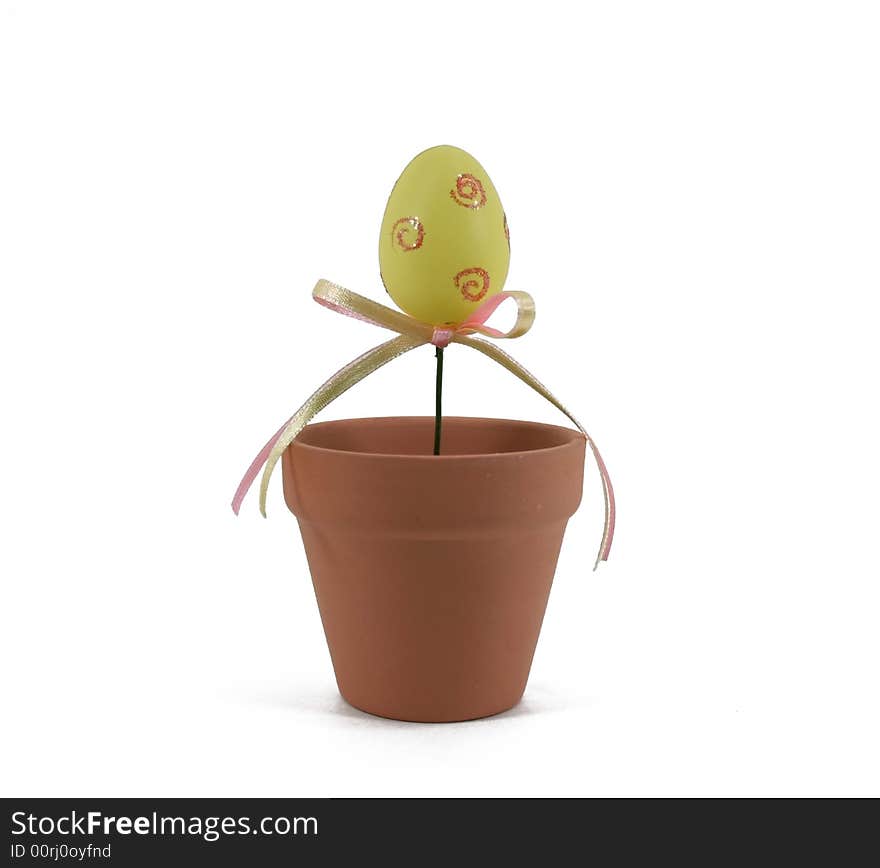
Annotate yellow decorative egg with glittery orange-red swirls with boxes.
[379,145,510,326]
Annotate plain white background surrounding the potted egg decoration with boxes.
[0,0,880,795]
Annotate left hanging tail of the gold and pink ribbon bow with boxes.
[253,336,427,516]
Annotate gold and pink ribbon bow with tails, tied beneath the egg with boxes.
[232,280,615,569]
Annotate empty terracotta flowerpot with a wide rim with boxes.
[283,417,586,722]
